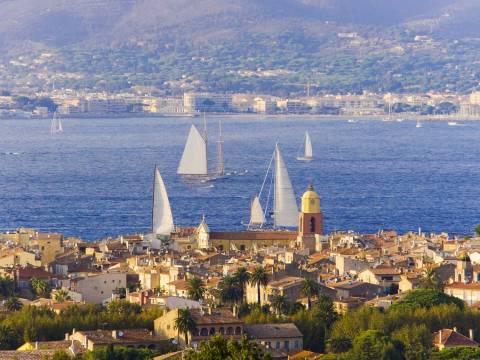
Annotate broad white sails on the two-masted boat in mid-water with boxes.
[177,125,208,175]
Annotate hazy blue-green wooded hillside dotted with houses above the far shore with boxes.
[0,0,480,92]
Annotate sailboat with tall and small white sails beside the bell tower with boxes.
[248,144,298,228]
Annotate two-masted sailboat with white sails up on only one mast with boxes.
[177,118,225,181]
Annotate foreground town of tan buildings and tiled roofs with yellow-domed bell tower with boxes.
[0,186,480,359]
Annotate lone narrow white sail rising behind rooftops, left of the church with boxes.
[152,167,173,235]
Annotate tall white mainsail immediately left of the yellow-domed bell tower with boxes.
[274,145,298,227]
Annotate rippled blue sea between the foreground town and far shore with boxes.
[0,118,480,239]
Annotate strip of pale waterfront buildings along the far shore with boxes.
[0,89,480,120]
